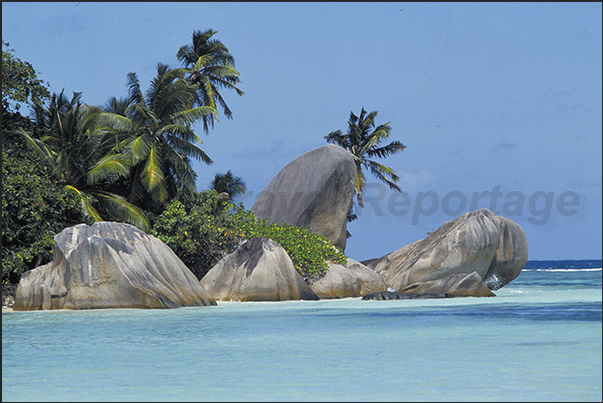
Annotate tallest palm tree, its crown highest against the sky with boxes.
[176,29,244,133]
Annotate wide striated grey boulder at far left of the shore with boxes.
[14,222,216,311]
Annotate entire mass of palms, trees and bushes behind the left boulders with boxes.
[2,30,346,284]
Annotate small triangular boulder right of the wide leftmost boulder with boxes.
[200,237,319,301]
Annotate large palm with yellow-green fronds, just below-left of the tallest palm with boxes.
[101,63,216,208]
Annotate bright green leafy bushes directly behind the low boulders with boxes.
[152,190,347,282]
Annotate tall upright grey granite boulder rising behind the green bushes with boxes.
[251,144,356,250]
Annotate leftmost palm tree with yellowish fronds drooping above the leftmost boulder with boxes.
[19,91,149,231]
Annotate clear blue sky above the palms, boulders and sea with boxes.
[2,2,602,260]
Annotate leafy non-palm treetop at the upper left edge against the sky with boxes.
[2,39,50,111]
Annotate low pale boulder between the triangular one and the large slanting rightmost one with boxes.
[310,258,387,299]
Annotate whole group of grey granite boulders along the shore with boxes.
[14,145,528,310]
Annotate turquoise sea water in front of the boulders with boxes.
[2,260,602,402]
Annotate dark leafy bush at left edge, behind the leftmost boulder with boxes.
[2,114,89,284]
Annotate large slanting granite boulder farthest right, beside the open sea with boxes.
[362,209,528,296]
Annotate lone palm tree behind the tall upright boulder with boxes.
[325,108,406,221]
